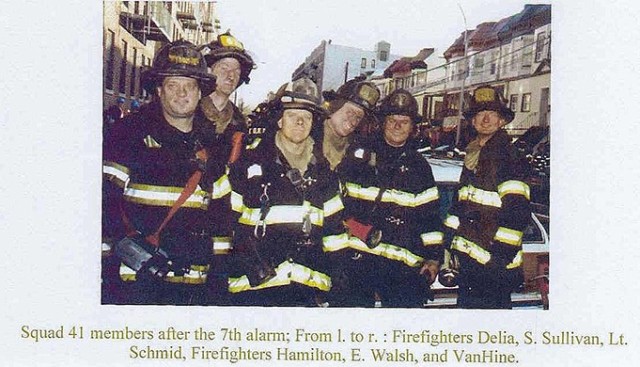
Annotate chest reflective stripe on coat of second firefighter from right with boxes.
[345,182,439,208]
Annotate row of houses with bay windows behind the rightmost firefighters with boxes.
[414,5,551,136]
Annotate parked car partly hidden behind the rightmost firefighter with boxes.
[424,152,549,309]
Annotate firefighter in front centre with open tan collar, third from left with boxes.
[222,78,347,306]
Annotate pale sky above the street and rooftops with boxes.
[217,0,550,106]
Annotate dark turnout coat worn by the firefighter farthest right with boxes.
[445,130,531,291]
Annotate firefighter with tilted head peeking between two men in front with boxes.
[322,77,380,170]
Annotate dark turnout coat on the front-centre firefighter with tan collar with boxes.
[222,134,346,293]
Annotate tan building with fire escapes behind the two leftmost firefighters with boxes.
[103,1,220,108]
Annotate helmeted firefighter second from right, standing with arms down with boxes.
[325,90,443,308]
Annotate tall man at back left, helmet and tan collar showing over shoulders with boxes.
[198,32,255,164]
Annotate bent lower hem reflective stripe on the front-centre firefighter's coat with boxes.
[229,261,331,293]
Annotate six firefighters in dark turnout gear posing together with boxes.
[102,33,530,308]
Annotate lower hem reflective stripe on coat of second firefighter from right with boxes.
[323,236,424,267]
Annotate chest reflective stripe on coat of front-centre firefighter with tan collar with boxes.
[238,202,324,227]
